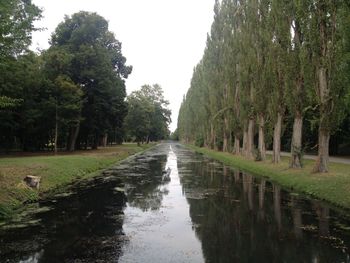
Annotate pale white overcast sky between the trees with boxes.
[32,0,215,131]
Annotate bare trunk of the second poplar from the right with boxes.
[290,111,303,168]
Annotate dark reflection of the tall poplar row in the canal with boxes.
[178,151,350,262]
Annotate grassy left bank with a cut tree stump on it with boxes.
[0,144,153,218]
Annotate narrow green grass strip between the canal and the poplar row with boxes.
[188,145,350,209]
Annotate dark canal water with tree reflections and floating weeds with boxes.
[0,144,350,262]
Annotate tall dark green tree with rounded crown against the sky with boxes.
[51,12,132,151]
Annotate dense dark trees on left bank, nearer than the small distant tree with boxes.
[0,0,168,151]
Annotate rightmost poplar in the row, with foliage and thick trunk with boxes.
[307,0,350,172]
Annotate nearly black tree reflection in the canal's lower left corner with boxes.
[0,175,125,262]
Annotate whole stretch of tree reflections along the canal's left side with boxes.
[0,145,171,263]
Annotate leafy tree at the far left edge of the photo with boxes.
[0,0,41,151]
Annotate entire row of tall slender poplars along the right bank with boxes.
[178,0,350,172]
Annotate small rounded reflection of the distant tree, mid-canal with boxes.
[126,154,168,211]
